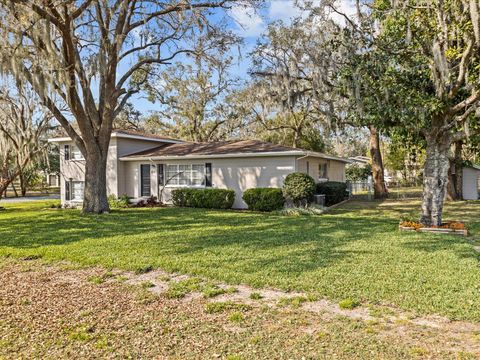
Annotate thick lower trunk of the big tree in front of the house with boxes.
[83,142,110,214]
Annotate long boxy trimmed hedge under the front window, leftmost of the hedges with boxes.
[172,189,235,209]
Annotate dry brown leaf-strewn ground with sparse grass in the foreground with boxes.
[0,260,480,359]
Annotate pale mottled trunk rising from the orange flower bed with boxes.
[420,131,450,226]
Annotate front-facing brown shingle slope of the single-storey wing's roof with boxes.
[126,140,302,158]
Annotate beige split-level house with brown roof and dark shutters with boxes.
[49,130,349,208]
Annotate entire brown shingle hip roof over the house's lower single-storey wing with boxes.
[121,140,349,162]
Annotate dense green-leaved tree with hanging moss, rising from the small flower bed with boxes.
[321,0,480,225]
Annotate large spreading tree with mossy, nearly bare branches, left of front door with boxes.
[0,0,253,213]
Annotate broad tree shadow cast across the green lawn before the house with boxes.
[0,204,392,272]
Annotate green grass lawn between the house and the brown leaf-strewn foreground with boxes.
[0,201,480,321]
